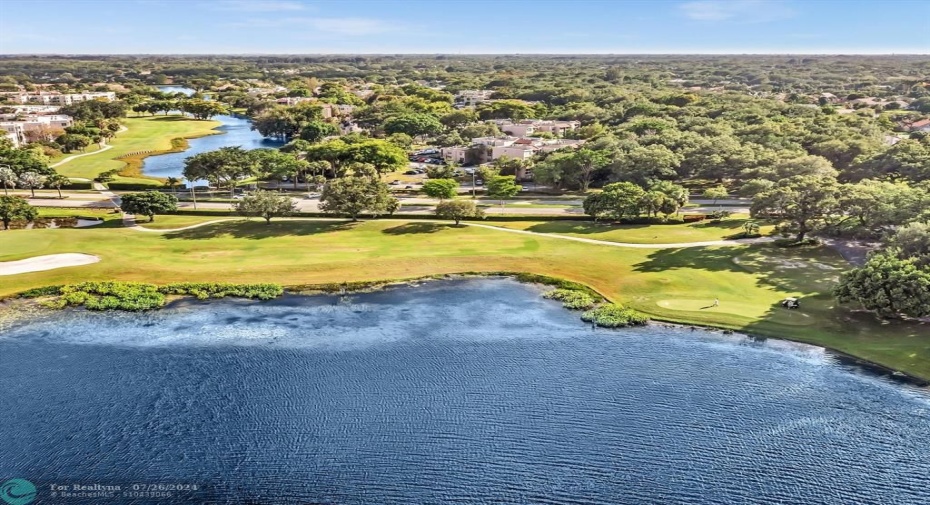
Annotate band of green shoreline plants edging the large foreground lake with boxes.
[0,272,930,388]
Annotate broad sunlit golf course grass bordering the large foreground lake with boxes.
[0,216,930,379]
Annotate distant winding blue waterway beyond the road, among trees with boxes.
[142,86,283,177]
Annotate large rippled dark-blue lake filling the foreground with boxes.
[0,280,930,505]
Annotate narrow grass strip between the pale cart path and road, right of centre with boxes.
[488,218,774,244]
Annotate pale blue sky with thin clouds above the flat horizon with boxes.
[0,0,930,54]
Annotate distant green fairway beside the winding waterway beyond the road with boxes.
[56,115,220,184]
